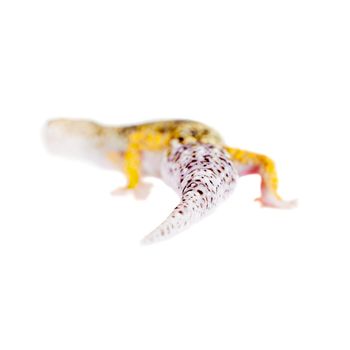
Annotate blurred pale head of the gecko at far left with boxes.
[43,119,123,166]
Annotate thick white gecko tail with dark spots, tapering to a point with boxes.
[142,143,238,244]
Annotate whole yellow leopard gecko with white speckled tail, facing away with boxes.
[44,119,296,244]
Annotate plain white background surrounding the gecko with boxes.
[0,0,350,350]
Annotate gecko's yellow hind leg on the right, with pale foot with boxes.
[225,147,297,209]
